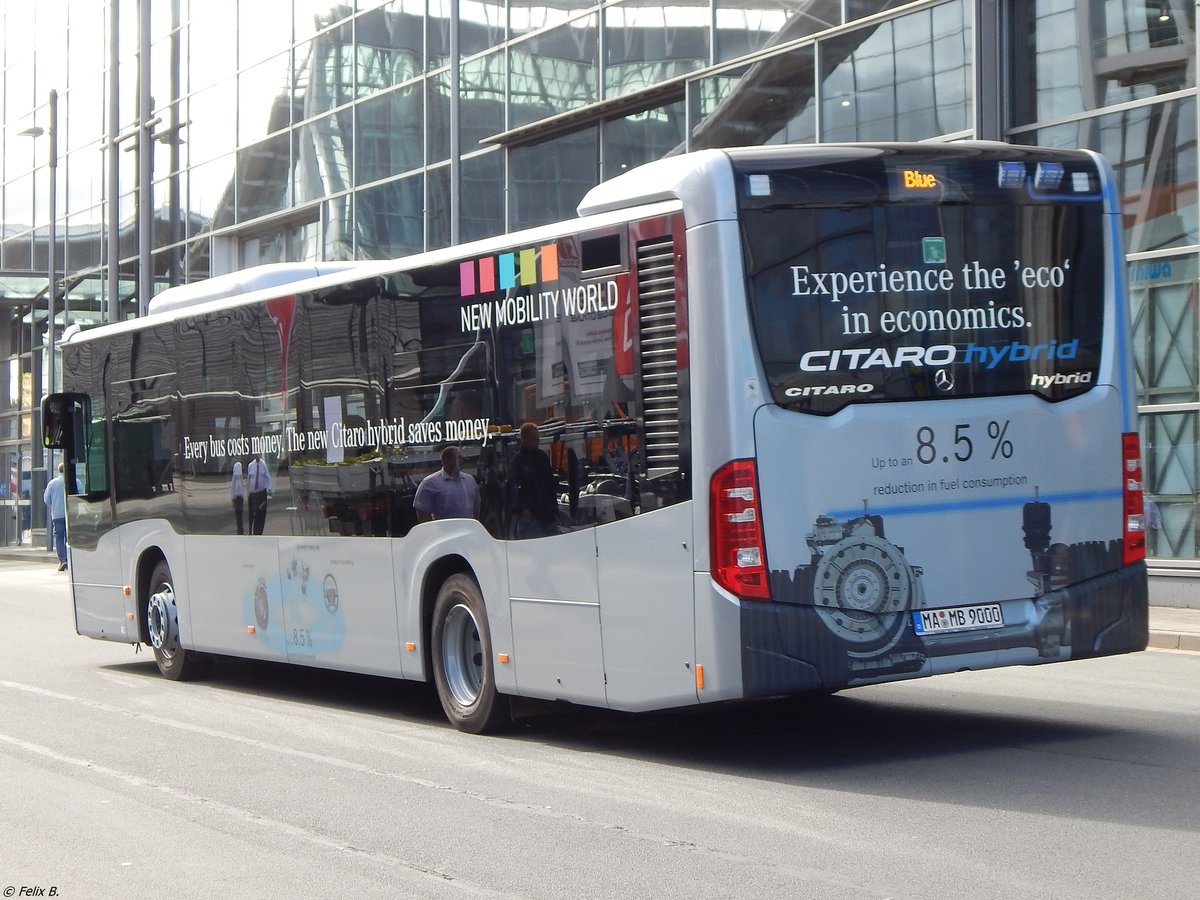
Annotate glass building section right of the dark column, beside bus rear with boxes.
[1012,0,1200,568]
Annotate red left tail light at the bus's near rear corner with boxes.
[708,460,770,600]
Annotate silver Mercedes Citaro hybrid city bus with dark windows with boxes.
[44,143,1147,731]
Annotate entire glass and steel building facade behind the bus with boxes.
[0,0,1200,593]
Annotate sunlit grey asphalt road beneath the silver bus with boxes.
[0,562,1200,900]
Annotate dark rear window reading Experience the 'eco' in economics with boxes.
[740,163,1105,414]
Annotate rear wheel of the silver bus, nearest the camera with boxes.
[430,575,510,734]
